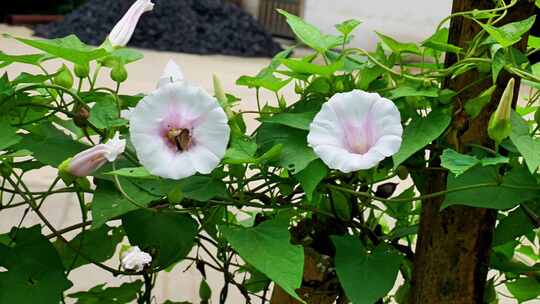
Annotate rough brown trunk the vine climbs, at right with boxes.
[410,0,534,304]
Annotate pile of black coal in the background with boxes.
[36,0,281,57]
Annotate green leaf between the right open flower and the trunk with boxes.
[393,109,451,167]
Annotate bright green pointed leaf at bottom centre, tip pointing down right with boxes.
[221,220,304,298]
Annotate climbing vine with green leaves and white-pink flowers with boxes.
[0,0,540,304]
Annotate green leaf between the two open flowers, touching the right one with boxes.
[257,123,317,173]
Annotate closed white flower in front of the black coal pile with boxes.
[108,0,154,47]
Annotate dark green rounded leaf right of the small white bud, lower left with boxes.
[122,209,198,269]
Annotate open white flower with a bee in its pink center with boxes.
[130,65,230,179]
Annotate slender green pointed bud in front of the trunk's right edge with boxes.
[488,78,515,144]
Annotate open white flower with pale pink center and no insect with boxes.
[308,90,403,173]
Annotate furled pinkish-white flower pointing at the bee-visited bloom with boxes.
[60,132,126,177]
